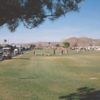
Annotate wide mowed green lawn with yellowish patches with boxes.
[0,50,100,100]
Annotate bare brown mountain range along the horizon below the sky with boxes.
[1,37,100,47]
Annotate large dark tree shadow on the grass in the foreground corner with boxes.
[59,87,100,100]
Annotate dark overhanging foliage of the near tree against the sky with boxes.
[0,0,83,32]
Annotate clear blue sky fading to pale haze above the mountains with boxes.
[0,0,100,43]
